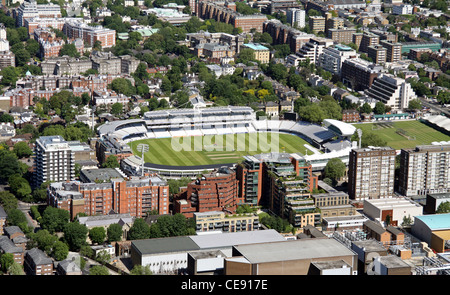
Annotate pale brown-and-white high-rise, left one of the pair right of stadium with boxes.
[348,147,396,200]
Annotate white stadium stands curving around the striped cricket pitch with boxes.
[98,106,355,178]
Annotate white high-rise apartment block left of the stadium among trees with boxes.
[33,135,75,186]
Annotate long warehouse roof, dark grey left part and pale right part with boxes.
[131,230,286,255]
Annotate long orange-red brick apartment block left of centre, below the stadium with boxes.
[47,177,169,219]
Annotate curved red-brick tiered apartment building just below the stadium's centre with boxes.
[173,167,238,218]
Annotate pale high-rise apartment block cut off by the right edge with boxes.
[399,145,450,196]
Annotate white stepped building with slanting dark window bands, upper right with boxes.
[365,74,417,111]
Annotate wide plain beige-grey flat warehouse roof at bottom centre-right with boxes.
[235,238,356,263]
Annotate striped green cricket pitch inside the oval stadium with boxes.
[129,133,312,166]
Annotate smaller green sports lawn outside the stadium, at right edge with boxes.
[353,121,450,150]
